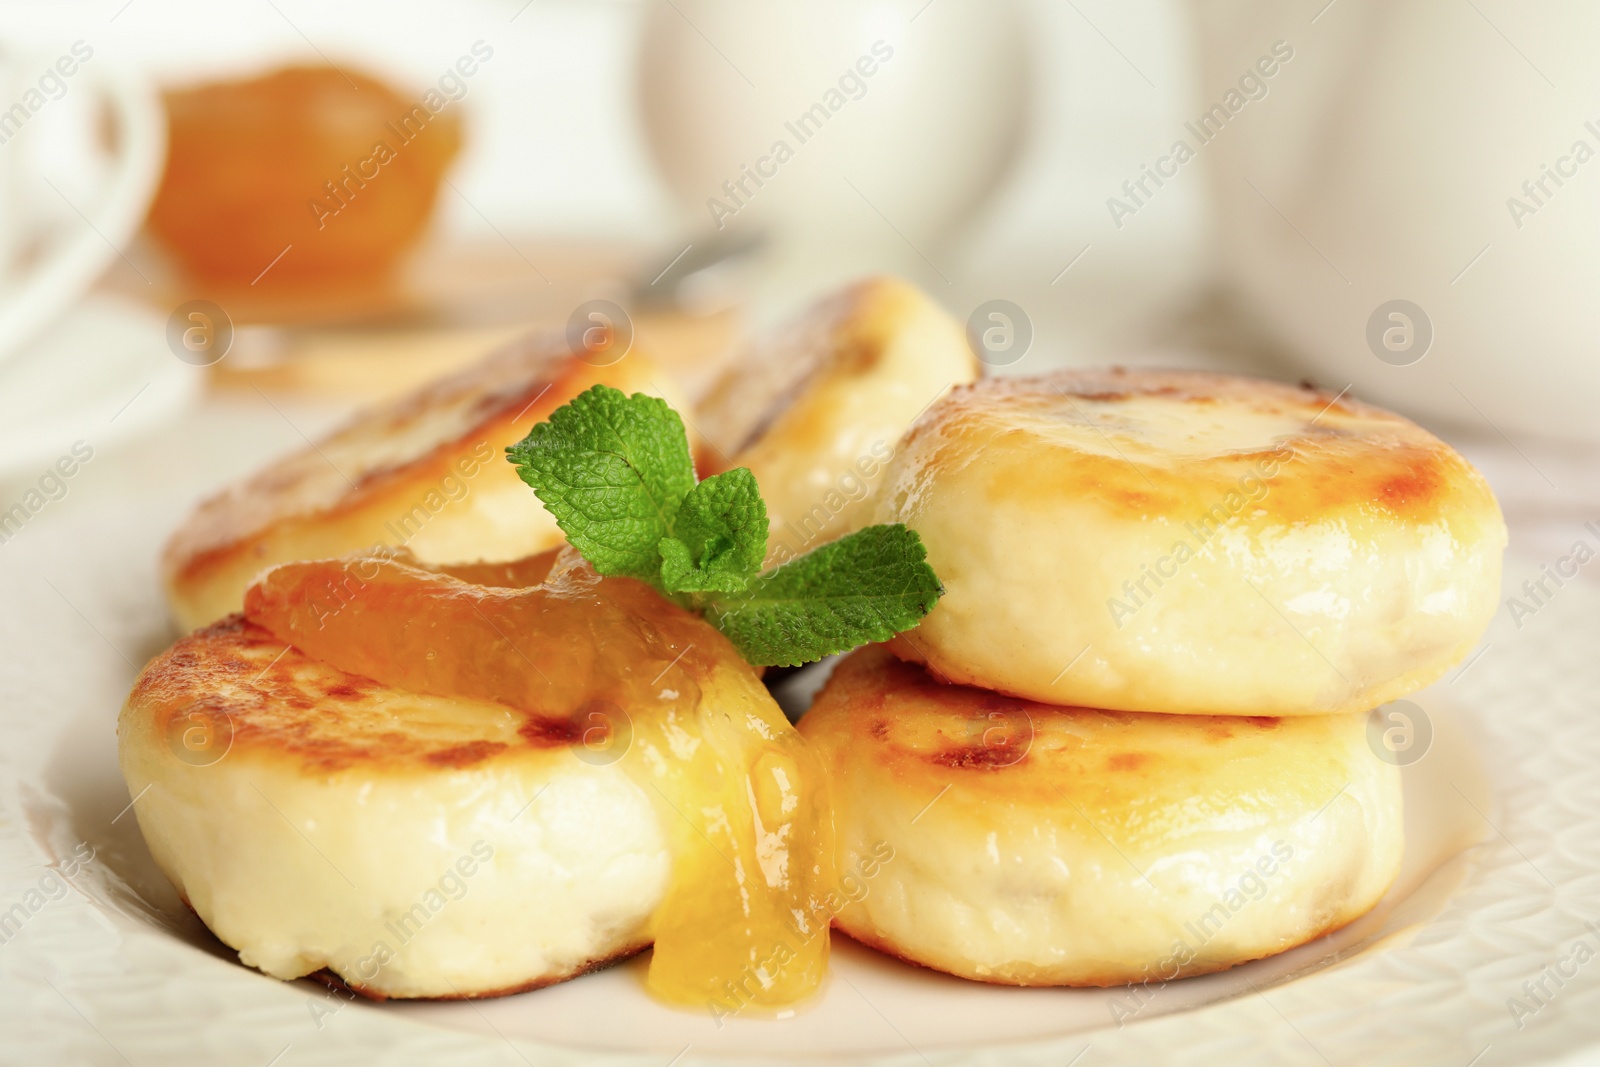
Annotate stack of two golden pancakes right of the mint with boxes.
[800,370,1506,985]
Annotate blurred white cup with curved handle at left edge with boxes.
[0,40,166,367]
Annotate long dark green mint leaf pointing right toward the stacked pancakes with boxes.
[706,523,944,667]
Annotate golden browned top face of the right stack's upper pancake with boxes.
[902,368,1494,523]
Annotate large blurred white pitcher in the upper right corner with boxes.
[1190,0,1600,442]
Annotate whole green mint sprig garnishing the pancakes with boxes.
[506,386,944,665]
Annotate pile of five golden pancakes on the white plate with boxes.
[120,278,1506,997]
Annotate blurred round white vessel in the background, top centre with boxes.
[638,0,1029,295]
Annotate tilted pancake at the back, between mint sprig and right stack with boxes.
[696,277,978,565]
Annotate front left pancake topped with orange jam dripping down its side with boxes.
[118,553,830,1006]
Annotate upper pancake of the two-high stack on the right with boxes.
[875,370,1506,715]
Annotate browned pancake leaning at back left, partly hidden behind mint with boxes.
[162,338,688,630]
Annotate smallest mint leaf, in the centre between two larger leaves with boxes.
[659,467,766,593]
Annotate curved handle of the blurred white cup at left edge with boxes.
[0,67,166,371]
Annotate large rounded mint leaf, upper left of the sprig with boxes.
[506,386,694,585]
